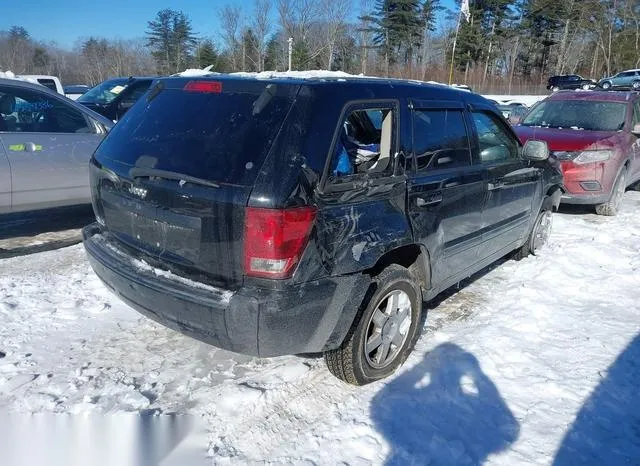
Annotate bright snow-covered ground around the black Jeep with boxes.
[0,192,640,465]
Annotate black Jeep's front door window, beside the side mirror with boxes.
[472,112,519,164]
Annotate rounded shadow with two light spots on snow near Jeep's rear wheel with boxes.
[371,343,520,465]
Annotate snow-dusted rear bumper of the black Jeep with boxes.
[82,224,371,357]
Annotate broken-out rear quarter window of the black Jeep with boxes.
[330,107,395,178]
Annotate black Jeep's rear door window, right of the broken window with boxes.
[413,110,471,170]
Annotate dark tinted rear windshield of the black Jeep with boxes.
[96,81,295,185]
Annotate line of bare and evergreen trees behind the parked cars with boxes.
[0,0,640,93]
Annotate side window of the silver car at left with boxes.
[0,87,91,133]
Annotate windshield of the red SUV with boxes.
[522,100,627,131]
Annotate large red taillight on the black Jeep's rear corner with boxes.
[244,207,316,278]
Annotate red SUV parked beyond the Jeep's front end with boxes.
[515,91,640,215]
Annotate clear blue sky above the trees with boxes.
[0,0,454,49]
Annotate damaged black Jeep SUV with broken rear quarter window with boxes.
[83,76,562,384]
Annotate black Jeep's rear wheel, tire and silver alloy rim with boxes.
[324,264,422,385]
